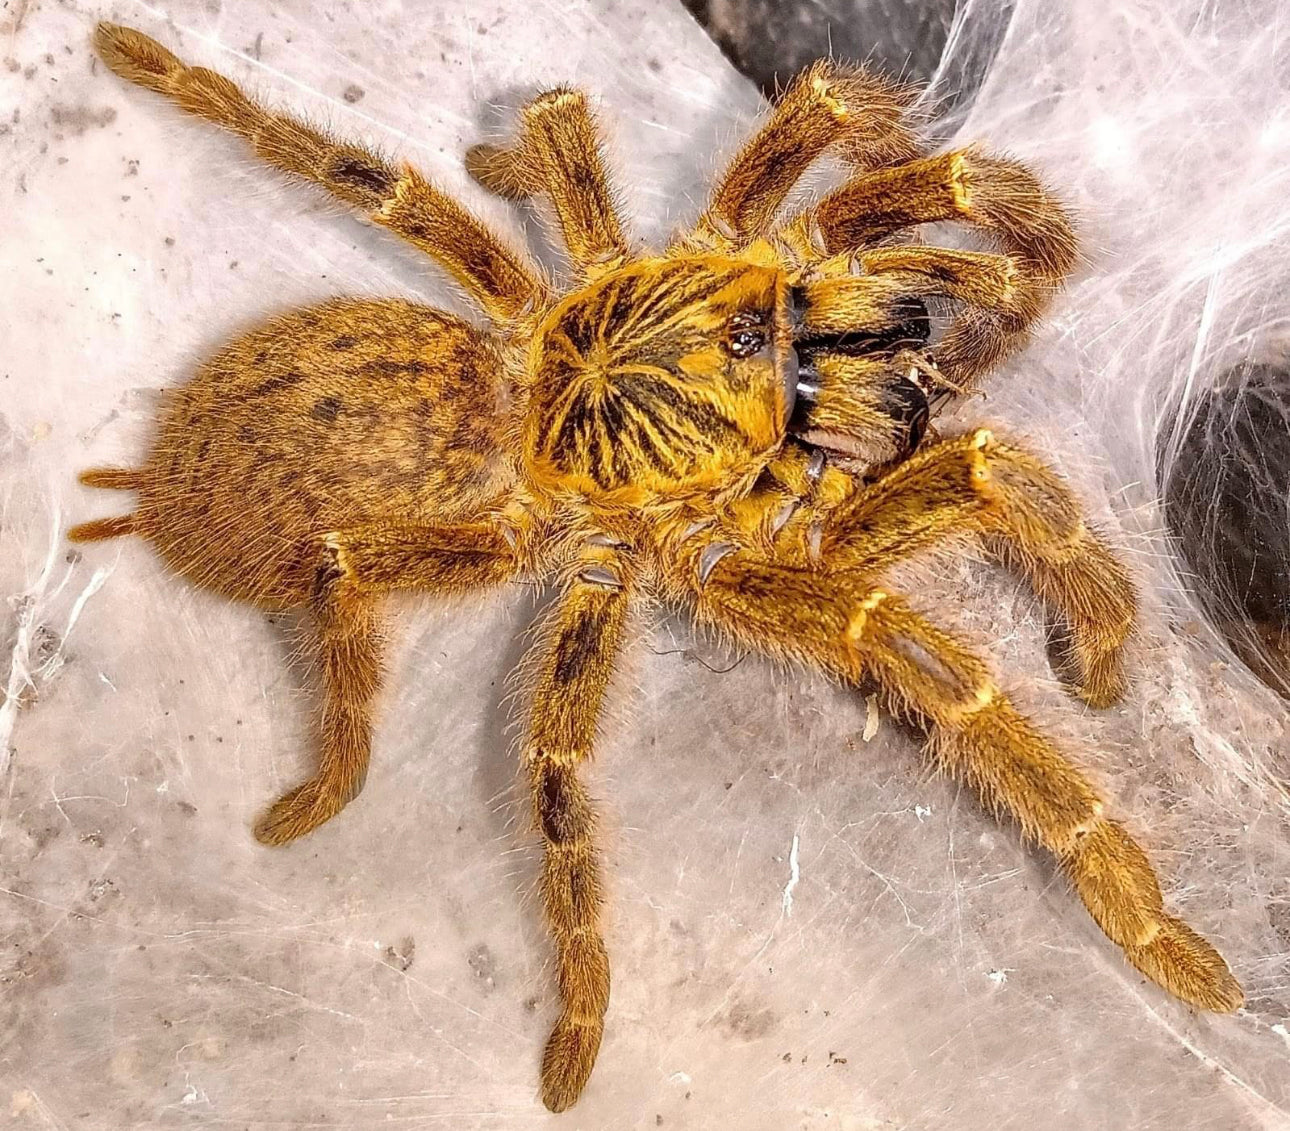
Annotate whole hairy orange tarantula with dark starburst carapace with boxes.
[71,25,1241,1110]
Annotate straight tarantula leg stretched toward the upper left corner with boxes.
[94,23,546,324]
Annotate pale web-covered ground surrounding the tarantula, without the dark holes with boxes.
[0,0,1290,1131]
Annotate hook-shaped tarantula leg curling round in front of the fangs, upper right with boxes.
[775,150,1077,384]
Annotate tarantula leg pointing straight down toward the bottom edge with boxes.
[524,565,630,1112]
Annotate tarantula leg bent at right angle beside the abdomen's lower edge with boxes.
[255,524,516,845]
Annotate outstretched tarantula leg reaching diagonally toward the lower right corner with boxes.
[679,552,1242,1011]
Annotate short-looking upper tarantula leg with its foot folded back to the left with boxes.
[466,88,630,279]
